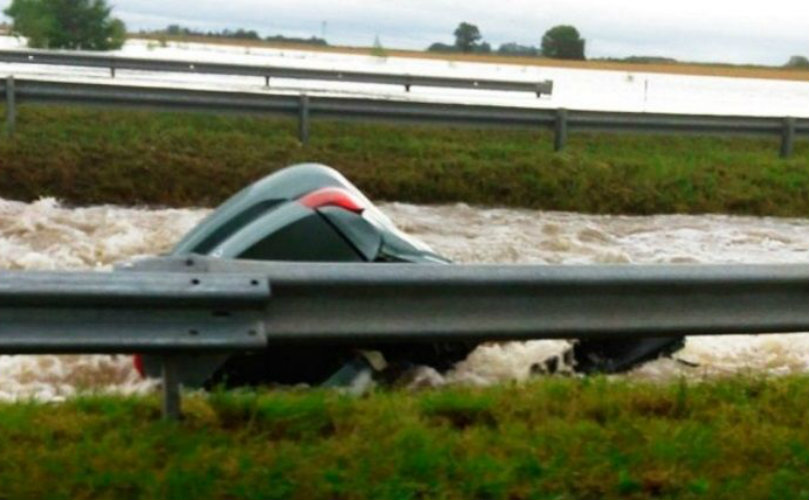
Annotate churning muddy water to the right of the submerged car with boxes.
[382,203,809,384]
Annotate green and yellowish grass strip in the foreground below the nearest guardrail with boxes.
[0,377,809,500]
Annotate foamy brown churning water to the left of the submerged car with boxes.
[0,198,206,401]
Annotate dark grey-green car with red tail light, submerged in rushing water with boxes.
[136,164,683,386]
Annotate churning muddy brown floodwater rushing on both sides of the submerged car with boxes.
[0,199,809,400]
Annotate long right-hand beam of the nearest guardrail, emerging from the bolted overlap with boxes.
[129,257,809,344]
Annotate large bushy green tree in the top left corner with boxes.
[3,0,126,50]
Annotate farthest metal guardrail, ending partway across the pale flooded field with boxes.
[0,50,553,97]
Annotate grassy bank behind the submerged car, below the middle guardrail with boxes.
[0,106,809,216]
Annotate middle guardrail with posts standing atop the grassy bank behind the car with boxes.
[0,77,809,157]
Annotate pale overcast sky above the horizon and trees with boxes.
[0,0,809,65]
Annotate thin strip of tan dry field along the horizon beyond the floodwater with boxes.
[130,34,809,81]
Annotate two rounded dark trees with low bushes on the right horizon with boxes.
[427,22,585,60]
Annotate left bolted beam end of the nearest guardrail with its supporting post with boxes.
[0,272,270,418]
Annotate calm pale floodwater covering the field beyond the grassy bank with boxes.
[0,36,809,117]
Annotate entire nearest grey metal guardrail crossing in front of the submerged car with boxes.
[0,256,809,418]
